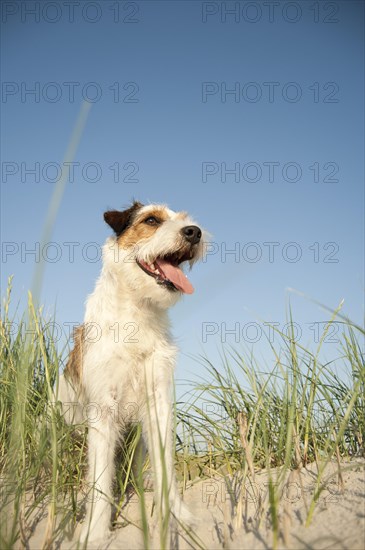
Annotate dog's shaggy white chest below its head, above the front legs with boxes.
[83,284,176,402]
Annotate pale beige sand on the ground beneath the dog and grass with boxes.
[12,459,365,550]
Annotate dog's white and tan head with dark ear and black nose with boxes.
[104,202,204,307]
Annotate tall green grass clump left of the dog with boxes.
[0,282,85,548]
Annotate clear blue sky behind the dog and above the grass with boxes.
[1,0,364,392]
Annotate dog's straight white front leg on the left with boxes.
[80,416,117,542]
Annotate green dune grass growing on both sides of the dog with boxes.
[0,281,365,548]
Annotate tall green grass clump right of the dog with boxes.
[179,310,365,547]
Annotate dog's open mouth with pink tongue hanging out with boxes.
[136,251,194,294]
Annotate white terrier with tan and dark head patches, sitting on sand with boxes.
[58,202,205,541]
